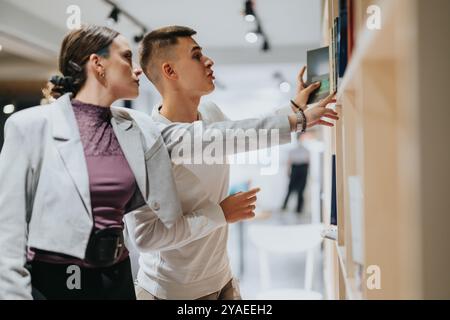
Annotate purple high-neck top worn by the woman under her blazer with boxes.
[29,100,136,267]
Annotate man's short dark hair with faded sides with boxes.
[139,26,197,85]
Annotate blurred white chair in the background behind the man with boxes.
[248,224,323,300]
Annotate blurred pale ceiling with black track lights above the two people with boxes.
[0,0,321,95]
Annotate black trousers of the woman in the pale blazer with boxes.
[31,258,136,300]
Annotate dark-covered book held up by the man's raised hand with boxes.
[306,47,330,104]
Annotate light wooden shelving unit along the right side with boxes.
[323,0,450,299]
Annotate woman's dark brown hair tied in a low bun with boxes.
[43,25,119,99]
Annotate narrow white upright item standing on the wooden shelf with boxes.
[348,176,364,265]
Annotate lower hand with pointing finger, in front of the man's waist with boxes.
[220,188,260,223]
